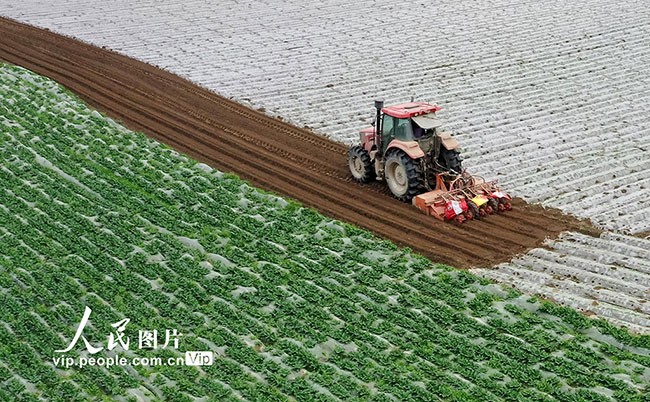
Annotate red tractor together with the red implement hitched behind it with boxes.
[348,101,511,222]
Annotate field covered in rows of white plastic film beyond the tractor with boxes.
[3,0,650,333]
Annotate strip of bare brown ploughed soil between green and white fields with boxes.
[0,18,597,267]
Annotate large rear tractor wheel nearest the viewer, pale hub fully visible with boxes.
[384,149,424,202]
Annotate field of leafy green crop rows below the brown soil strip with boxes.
[0,61,650,401]
